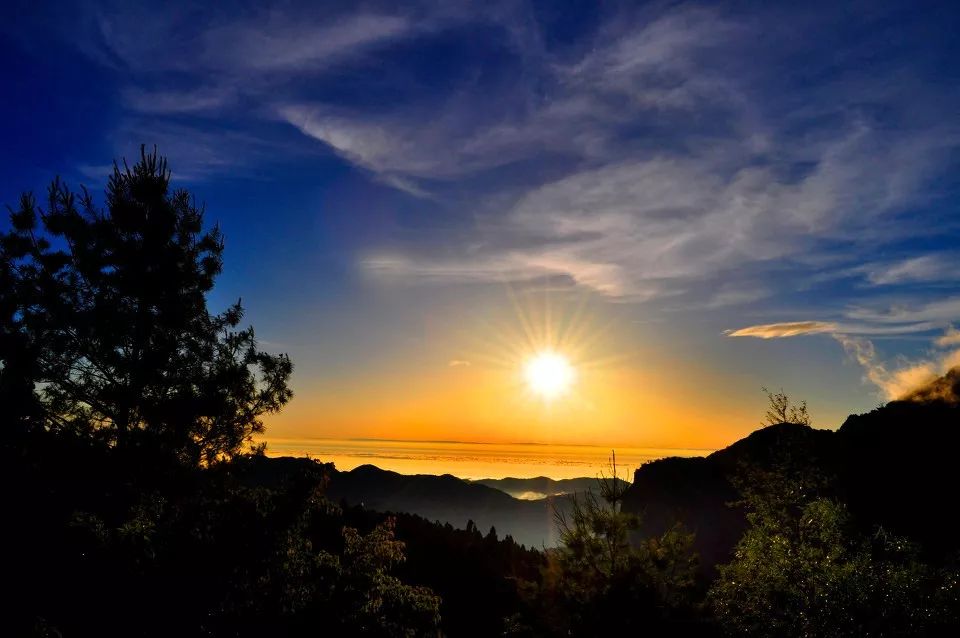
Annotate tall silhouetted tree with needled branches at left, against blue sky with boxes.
[0,148,292,465]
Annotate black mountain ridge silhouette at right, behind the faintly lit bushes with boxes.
[623,369,960,571]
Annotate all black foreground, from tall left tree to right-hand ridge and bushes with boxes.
[0,154,960,636]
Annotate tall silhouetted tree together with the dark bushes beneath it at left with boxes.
[0,152,439,636]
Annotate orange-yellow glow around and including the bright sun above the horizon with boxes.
[265,295,756,475]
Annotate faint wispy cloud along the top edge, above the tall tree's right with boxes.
[77,3,418,75]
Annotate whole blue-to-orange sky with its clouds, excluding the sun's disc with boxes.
[0,0,960,448]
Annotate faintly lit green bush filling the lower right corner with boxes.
[709,466,960,636]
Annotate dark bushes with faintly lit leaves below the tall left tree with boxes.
[42,466,439,637]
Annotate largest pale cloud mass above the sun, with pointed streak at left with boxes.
[294,9,956,300]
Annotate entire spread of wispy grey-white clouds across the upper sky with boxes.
[50,0,960,322]
